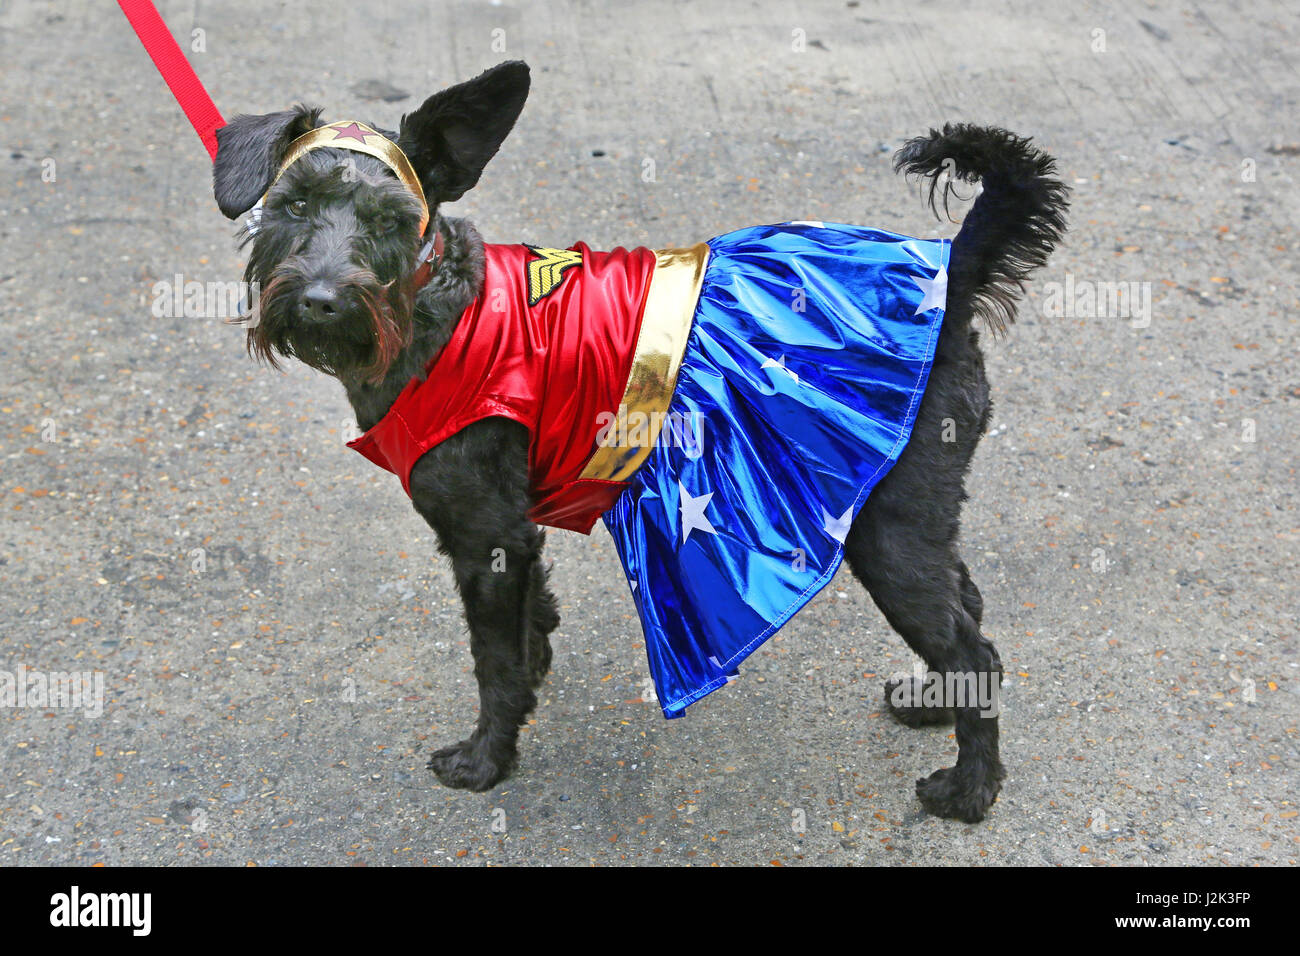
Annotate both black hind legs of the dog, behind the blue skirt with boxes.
[845,308,1002,822]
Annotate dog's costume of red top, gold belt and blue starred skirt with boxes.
[348,222,950,717]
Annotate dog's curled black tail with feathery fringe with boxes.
[894,124,1070,334]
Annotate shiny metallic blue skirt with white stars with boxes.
[605,222,950,717]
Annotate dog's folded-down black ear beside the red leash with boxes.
[212,105,321,219]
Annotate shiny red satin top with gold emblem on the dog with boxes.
[348,242,655,535]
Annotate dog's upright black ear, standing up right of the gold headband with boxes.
[398,60,529,206]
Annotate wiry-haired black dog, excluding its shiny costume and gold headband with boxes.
[213,62,1067,822]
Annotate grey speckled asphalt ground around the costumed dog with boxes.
[0,0,1300,866]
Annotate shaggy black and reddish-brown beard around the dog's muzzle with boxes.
[248,264,415,385]
